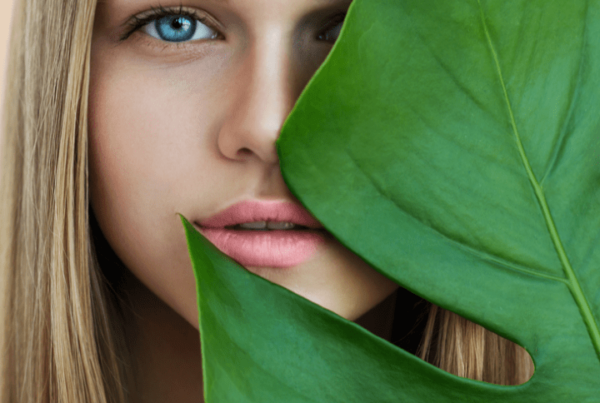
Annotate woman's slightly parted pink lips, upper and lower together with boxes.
[197,200,325,268]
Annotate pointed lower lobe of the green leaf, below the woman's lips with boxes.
[182,217,528,403]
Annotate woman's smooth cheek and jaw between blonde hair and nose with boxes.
[89,57,227,326]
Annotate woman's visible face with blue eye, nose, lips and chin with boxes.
[89,0,397,327]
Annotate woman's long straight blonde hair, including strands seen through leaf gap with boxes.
[0,0,529,403]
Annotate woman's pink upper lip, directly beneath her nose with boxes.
[198,200,323,229]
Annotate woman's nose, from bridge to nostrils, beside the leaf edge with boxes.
[217,31,299,165]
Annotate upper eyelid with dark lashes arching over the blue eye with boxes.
[120,6,224,42]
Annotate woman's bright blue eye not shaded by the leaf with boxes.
[142,15,217,42]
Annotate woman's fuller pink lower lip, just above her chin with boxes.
[196,226,325,268]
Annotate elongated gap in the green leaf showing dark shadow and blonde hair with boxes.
[356,288,534,385]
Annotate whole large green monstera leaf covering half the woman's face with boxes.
[184,0,600,403]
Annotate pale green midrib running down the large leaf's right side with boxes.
[477,0,600,359]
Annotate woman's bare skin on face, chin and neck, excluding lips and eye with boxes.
[90,0,397,402]
